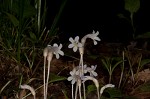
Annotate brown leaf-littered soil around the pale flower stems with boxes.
[0,42,150,99]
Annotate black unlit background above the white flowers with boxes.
[47,0,150,42]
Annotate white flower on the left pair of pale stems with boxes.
[53,44,64,59]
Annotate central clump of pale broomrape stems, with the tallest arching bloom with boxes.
[67,30,112,99]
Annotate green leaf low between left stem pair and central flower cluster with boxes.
[49,73,67,83]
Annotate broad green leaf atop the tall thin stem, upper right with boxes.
[125,0,140,13]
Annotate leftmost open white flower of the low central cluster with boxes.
[67,68,79,84]
